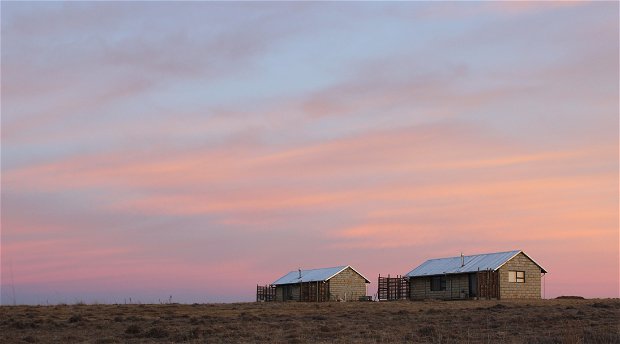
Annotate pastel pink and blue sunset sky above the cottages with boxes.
[0,1,620,304]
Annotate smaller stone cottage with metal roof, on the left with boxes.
[272,265,370,302]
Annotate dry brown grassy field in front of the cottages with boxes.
[0,299,620,343]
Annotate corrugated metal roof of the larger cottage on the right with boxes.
[406,250,546,277]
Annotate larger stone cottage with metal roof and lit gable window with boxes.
[406,250,547,300]
